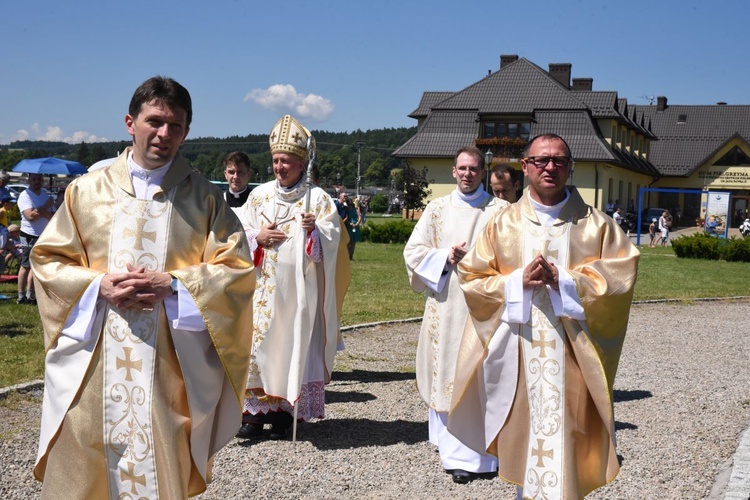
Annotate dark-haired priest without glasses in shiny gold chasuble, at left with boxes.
[32,77,254,499]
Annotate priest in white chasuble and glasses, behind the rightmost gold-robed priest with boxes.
[404,147,508,483]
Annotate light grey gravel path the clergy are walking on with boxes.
[0,301,750,499]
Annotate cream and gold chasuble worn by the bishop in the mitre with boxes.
[240,181,350,420]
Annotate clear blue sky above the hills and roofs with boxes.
[0,0,750,144]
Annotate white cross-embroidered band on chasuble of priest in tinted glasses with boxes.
[520,219,570,498]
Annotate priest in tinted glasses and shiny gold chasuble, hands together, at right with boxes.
[448,134,639,499]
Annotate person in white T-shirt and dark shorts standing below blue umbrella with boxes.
[17,174,55,304]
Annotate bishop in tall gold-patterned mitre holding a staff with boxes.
[237,115,349,439]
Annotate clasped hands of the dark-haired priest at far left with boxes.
[99,264,172,309]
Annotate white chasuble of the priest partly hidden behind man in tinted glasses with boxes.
[404,193,508,412]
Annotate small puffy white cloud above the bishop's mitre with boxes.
[244,84,333,121]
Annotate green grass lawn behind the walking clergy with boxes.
[0,242,750,387]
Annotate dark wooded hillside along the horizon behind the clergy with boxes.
[0,127,417,190]
